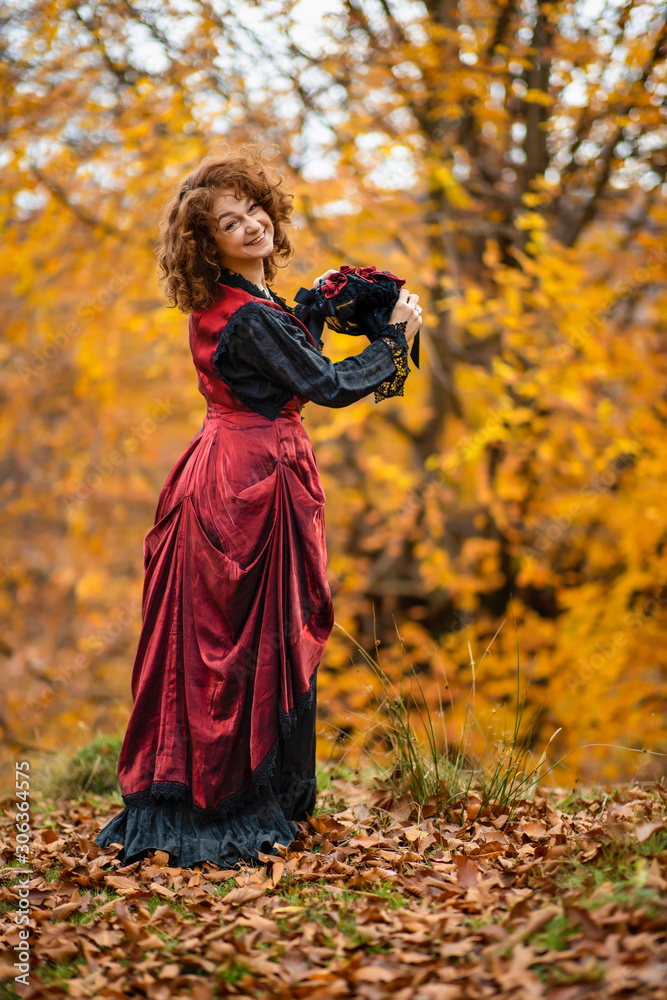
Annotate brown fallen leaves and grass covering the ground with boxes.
[0,781,667,1000]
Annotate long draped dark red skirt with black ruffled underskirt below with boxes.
[95,390,333,867]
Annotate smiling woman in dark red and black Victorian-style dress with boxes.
[96,147,421,868]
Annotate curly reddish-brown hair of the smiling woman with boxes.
[158,143,293,313]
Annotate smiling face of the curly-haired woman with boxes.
[211,189,273,272]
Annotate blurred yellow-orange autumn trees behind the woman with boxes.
[0,0,667,796]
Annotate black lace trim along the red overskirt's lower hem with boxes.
[122,667,317,820]
